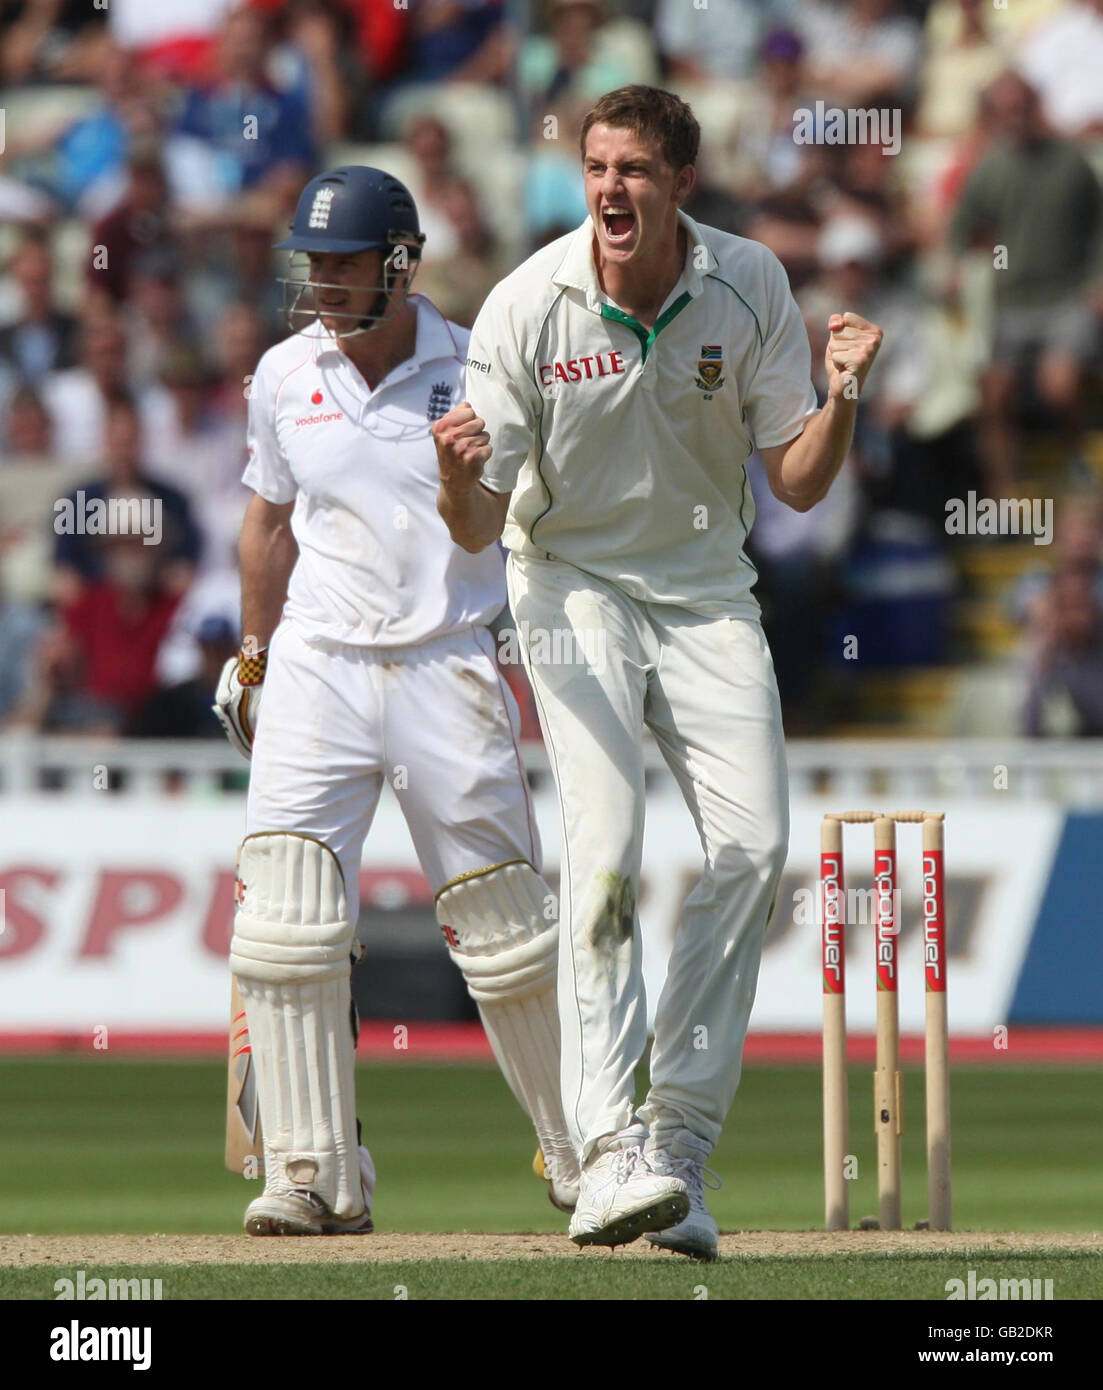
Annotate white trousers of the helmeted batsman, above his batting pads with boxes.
[246,619,540,922]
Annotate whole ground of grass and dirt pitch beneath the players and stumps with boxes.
[0,1054,1103,1307]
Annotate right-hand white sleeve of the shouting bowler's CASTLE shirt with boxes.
[743,256,818,449]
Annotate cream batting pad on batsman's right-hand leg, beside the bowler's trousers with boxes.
[436,860,577,1173]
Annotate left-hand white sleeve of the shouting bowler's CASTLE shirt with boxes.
[464,287,540,492]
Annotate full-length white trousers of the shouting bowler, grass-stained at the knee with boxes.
[508,555,789,1162]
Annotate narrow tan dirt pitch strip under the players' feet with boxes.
[0,1230,1103,1268]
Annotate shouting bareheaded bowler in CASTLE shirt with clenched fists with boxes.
[432,86,881,1259]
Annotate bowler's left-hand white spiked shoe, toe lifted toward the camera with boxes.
[567,1143,689,1245]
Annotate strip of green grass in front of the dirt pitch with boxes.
[0,1251,1103,1315]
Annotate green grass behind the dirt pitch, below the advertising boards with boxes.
[0,1054,1103,1234]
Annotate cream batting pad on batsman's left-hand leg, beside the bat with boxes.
[231,833,364,1219]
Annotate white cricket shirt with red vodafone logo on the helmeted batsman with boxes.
[243,295,506,646]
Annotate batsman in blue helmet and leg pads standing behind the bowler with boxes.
[215,165,578,1236]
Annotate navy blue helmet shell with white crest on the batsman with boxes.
[275,164,425,256]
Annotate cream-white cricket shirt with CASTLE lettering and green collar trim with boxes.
[464,213,817,616]
